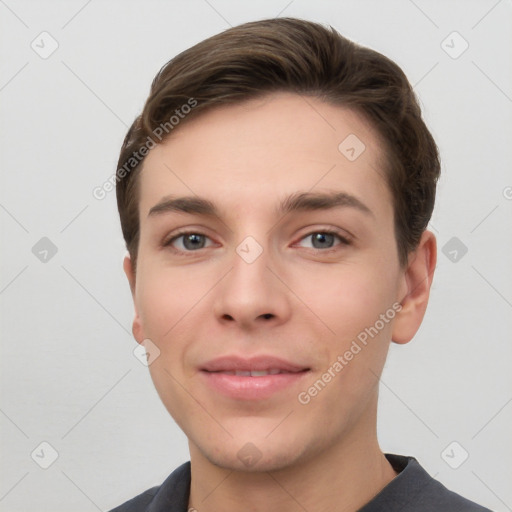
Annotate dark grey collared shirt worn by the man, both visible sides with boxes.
[110,454,491,512]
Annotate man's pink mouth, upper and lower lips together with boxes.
[200,356,310,400]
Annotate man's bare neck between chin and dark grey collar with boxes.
[189,404,397,512]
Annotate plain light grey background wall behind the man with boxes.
[0,0,512,512]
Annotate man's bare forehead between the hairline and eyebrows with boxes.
[139,93,391,219]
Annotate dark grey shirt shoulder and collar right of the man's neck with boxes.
[360,454,491,512]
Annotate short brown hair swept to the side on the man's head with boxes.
[116,18,440,269]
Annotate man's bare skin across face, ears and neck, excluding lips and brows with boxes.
[124,93,436,512]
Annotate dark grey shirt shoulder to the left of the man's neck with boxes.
[109,461,190,512]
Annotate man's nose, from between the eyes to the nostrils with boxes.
[213,237,292,330]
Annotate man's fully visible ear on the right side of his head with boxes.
[391,230,437,344]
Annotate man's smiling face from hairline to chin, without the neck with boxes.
[125,94,416,470]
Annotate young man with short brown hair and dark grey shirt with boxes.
[114,18,487,512]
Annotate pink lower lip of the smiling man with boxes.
[201,371,309,400]
